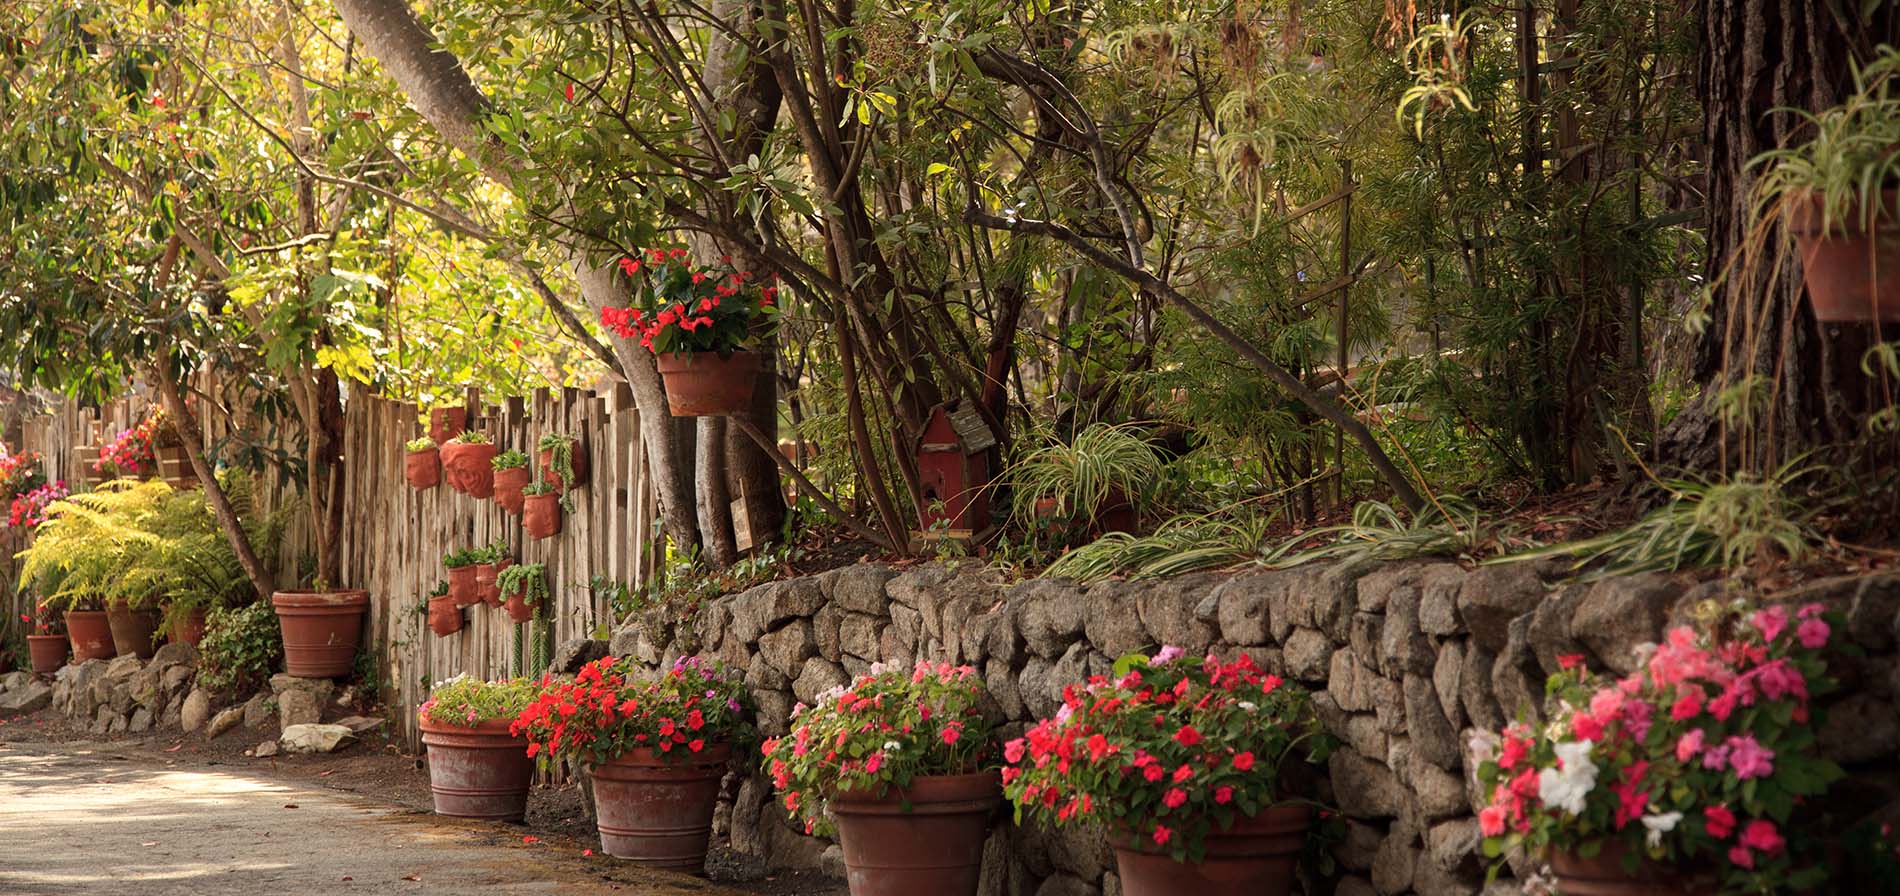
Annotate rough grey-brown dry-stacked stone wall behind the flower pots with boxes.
[612,562,1900,896]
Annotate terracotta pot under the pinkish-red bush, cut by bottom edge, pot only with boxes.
[1112,805,1313,896]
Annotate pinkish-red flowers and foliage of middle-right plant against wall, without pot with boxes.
[1003,647,1330,856]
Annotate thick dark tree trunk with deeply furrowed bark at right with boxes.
[1659,0,1900,471]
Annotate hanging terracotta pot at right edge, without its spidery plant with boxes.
[1788,190,1900,323]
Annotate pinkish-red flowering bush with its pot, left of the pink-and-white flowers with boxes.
[1003,647,1332,896]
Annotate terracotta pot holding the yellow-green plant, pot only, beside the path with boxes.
[422,718,534,822]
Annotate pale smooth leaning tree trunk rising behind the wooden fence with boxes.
[336,0,699,551]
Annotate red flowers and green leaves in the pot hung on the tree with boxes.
[600,249,779,355]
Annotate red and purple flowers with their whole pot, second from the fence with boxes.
[513,657,752,873]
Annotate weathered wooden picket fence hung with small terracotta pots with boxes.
[0,377,663,748]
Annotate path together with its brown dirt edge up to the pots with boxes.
[0,712,844,896]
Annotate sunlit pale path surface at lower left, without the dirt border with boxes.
[0,742,752,896]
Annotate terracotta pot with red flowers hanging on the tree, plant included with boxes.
[600,249,779,418]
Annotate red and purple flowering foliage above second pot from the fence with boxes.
[509,657,751,765]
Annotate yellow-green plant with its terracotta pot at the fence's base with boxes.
[416,676,536,822]
